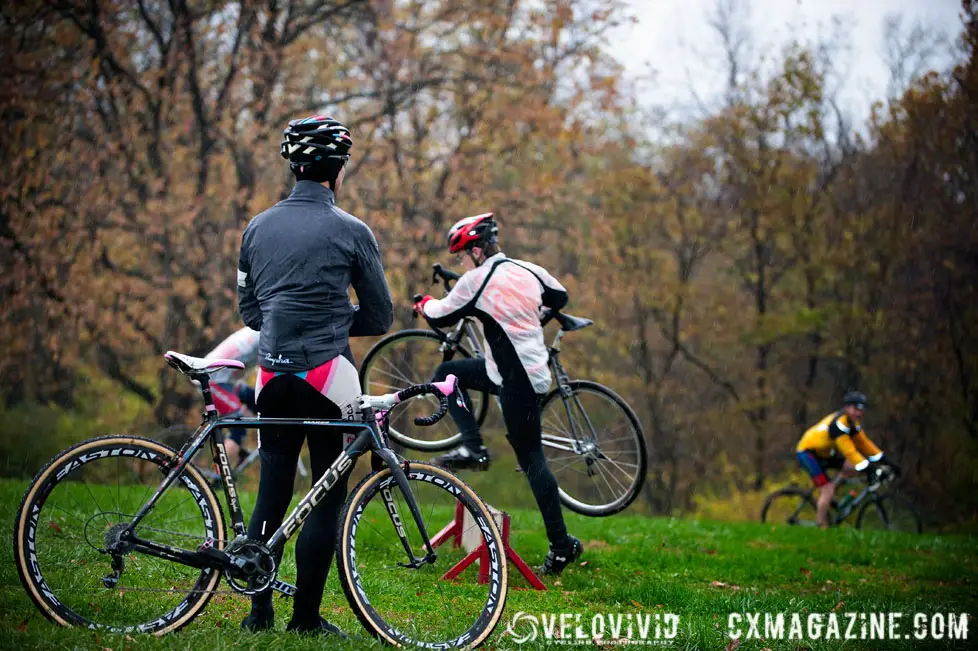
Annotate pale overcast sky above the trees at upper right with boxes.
[611,0,961,123]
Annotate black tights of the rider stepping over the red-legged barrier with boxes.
[435,358,567,547]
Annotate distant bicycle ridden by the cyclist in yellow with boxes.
[761,469,923,533]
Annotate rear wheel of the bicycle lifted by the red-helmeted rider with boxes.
[541,380,648,517]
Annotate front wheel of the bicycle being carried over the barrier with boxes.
[360,330,489,452]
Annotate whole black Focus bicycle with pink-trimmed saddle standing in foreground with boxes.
[13,352,507,648]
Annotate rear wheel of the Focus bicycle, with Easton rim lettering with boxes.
[14,436,225,635]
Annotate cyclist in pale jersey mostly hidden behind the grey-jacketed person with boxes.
[204,326,258,464]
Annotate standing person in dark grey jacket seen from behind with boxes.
[238,115,394,636]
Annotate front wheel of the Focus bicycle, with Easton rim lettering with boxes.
[337,462,507,649]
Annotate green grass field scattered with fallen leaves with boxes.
[0,478,978,651]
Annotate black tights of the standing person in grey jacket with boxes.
[248,374,349,625]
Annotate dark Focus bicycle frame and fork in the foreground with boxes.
[114,376,436,594]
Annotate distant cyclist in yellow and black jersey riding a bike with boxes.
[796,391,900,528]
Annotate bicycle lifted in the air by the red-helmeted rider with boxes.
[360,264,648,516]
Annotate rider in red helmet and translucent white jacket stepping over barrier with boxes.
[414,218,583,574]
